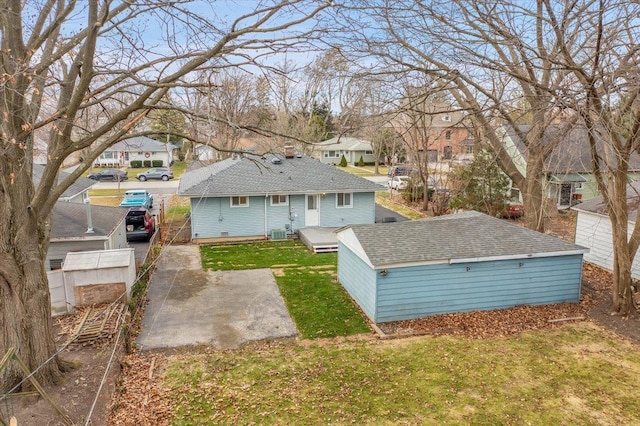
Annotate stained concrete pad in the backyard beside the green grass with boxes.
[137,245,298,350]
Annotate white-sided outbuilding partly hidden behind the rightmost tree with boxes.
[572,182,640,279]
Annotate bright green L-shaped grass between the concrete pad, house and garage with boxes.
[200,241,370,339]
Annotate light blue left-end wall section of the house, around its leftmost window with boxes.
[191,197,264,238]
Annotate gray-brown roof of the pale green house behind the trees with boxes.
[505,125,640,174]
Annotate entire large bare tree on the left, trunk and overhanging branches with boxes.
[0,0,328,390]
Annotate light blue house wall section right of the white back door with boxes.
[320,192,376,228]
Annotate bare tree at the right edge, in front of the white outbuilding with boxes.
[544,1,640,316]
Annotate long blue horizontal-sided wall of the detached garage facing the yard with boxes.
[372,250,582,322]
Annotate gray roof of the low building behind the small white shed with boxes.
[51,202,129,241]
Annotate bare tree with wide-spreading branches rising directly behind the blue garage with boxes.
[336,0,579,230]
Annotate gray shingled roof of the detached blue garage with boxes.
[341,211,587,267]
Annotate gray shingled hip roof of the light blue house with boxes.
[178,154,386,197]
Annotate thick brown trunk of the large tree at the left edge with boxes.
[0,168,63,392]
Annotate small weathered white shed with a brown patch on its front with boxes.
[62,248,136,307]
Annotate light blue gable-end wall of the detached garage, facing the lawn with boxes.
[338,242,376,320]
